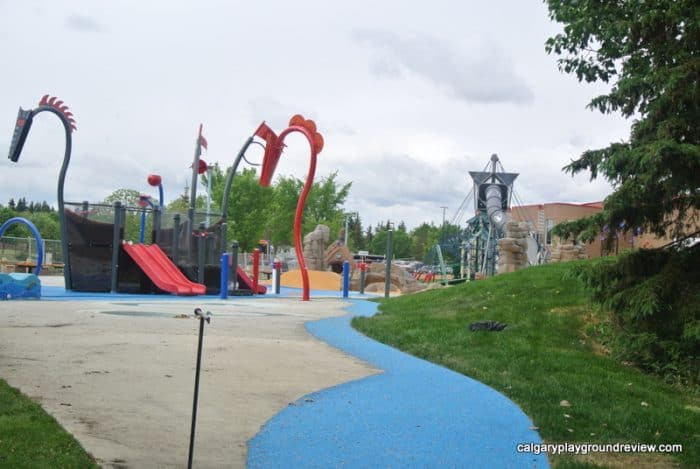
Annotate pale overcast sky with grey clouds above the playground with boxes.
[0,0,630,227]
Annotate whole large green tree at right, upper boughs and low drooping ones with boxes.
[546,0,700,384]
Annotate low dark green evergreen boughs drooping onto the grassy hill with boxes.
[573,245,700,385]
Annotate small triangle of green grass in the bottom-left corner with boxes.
[0,379,99,469]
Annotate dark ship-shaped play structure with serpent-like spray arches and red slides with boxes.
[8,95,323,300]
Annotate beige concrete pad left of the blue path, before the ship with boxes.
[0,288,378,468]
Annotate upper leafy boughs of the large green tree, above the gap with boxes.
[546,0,700,245]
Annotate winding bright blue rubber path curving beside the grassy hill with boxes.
[248,301,548,468]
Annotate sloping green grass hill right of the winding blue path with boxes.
[353,264,700,468]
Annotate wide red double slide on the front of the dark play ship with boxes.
[123,243,207,295]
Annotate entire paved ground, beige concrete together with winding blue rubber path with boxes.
[0,276,547,468]
